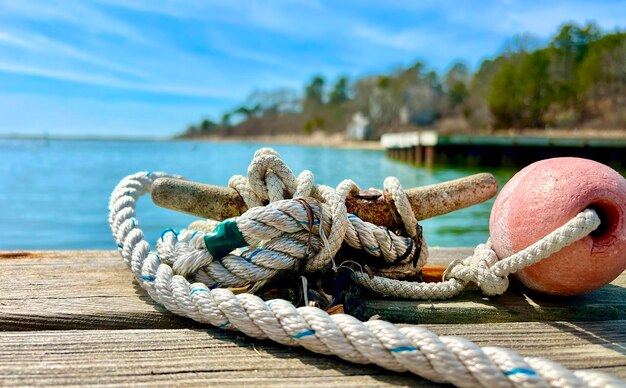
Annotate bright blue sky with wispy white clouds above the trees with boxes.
[0,0,626,137]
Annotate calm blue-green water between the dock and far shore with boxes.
[0,140,514,250]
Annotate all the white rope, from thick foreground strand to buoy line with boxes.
[109,150,621,387]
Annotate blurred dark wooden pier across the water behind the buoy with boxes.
[381,131,626,169]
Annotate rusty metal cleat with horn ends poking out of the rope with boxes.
[152,173,498,230]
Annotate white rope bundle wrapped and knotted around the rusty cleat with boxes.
[151,149,428,287]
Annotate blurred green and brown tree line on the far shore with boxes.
[179,23,626,138]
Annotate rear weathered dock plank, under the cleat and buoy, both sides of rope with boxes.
[0,248,626,330]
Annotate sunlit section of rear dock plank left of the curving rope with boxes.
[0,251,195,330]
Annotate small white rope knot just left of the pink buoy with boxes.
[443,241,509,296]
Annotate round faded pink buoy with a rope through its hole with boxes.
[489,158,626,295]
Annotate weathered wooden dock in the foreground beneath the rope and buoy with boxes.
[0,248,626,386]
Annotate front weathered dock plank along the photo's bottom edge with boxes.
[0,321,626,386]
